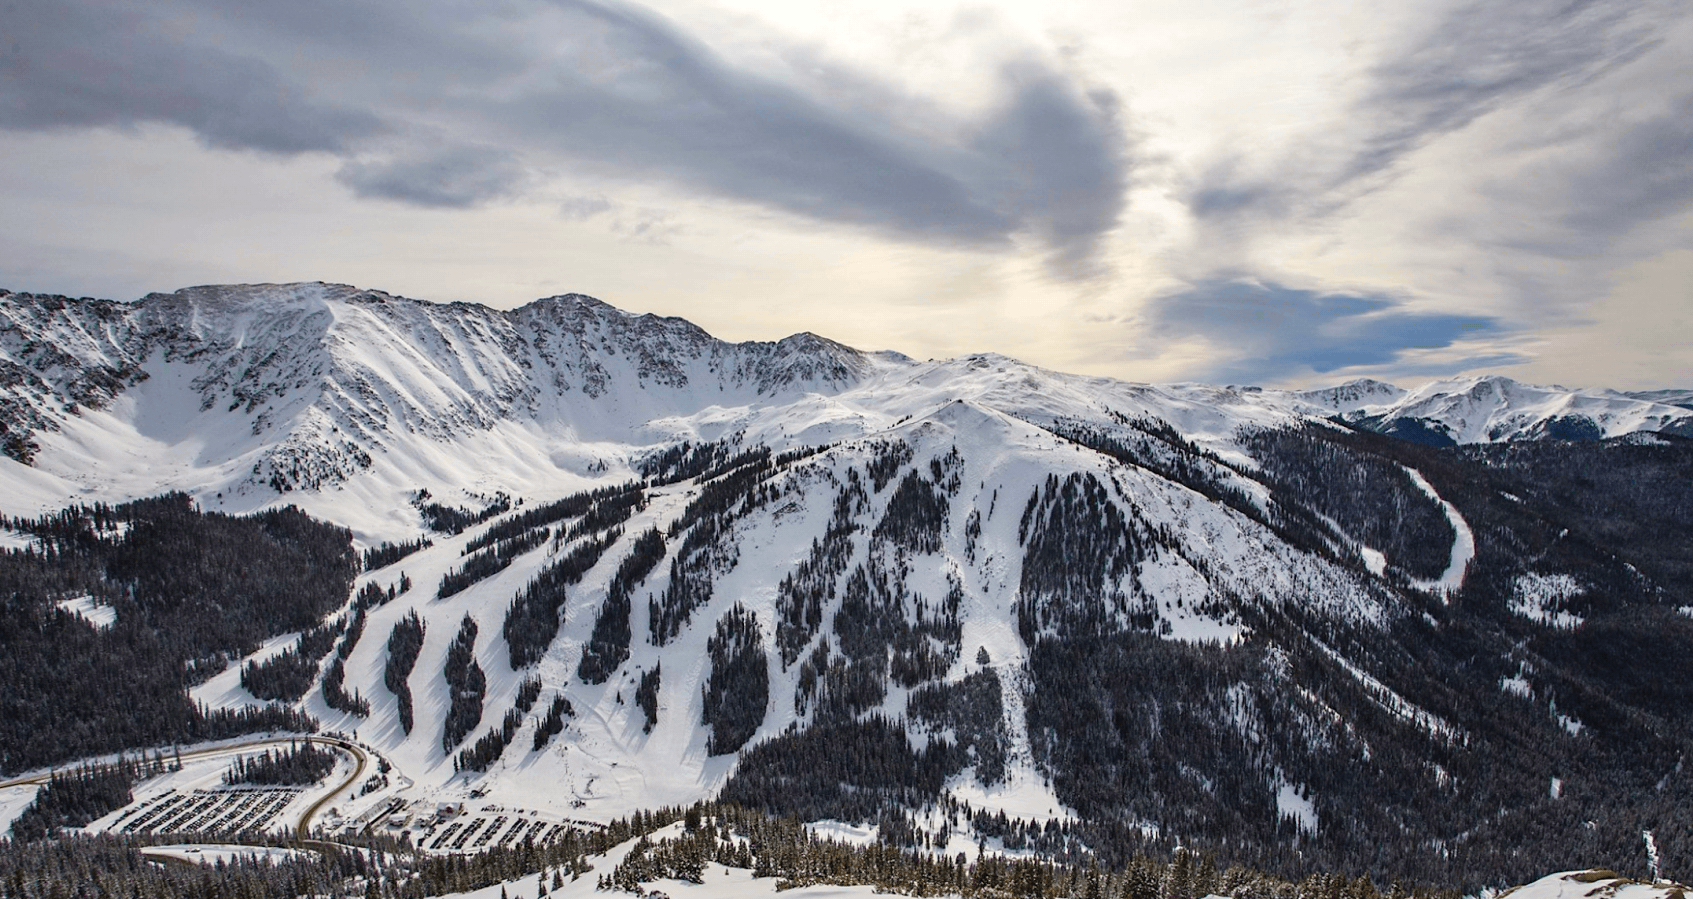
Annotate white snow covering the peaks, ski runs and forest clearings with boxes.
[0,284,1693,863]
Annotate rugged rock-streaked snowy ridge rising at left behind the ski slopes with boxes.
[0,283,872,493]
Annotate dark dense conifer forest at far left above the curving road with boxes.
[0,494,345,772]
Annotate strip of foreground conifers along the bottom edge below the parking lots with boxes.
[0,802,1483,899]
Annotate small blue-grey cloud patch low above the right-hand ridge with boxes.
[1146,281,1500,383]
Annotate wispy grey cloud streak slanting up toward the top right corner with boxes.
[1188,0,1664,218]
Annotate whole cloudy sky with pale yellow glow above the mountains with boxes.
[0,0,1693,389]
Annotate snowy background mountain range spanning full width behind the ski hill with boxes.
[0,283,1693,538]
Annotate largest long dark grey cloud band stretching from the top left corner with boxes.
[0,0,1128,273]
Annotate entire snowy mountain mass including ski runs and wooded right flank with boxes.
[0,284,1693,884]
